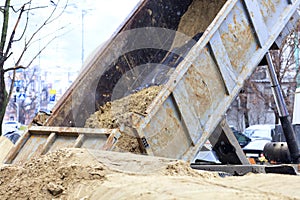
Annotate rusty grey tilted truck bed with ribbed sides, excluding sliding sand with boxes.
[5,0,300,163]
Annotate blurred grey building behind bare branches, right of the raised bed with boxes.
[226,66,296,131]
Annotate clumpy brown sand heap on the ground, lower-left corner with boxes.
[0,149,106,199]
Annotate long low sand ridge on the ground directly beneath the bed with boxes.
[0,149,212,199]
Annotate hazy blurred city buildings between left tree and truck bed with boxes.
[4,66,78,124]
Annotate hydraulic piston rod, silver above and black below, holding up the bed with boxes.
[266,52,300,163]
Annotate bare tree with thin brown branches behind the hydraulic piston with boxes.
[239,32,299,127]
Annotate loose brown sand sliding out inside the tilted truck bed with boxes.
[85,86,162,154]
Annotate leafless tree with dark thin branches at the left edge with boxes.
[0,0,68,134]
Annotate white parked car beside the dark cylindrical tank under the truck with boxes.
[243,124,275,162]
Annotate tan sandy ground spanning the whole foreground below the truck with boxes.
[0,149,300,200]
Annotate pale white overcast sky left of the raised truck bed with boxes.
[6,0,139,71]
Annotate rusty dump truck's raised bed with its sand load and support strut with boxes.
[4,0,300,173]
